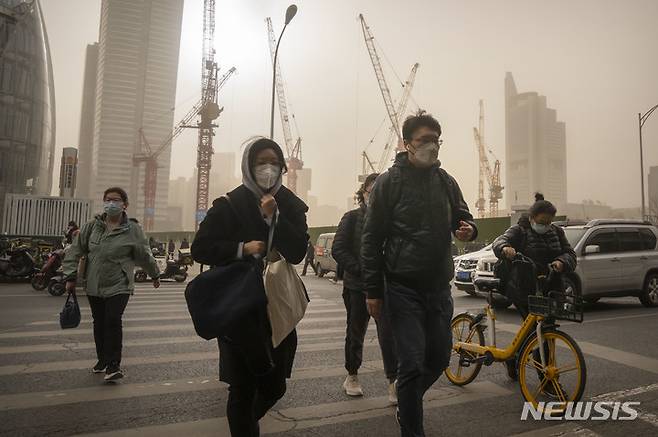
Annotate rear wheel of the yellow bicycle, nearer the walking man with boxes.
[445,314,484,385]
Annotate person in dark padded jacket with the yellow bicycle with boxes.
[493,193,577,380]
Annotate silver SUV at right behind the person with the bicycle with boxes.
[474,219,658,307]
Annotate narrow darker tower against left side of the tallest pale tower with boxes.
[76,43,98,199]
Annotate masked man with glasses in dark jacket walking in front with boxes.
[361,112,477,437]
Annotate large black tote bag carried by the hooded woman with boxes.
[185,261,267,340]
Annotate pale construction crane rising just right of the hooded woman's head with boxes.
[265,17,304,194]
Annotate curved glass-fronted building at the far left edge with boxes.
[0,0,55,228]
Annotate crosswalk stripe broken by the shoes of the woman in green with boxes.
[0,341,379,376]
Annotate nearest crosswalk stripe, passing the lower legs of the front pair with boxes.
[78,381,512,437]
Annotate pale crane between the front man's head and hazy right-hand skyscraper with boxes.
[473,100,503,218]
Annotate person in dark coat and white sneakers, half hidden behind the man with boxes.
[332,173,398,404]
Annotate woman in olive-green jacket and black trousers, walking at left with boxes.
[63,187,160,381]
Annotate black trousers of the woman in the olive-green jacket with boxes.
[87,294,130,366]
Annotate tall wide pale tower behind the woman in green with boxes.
[90,0,183,229]
